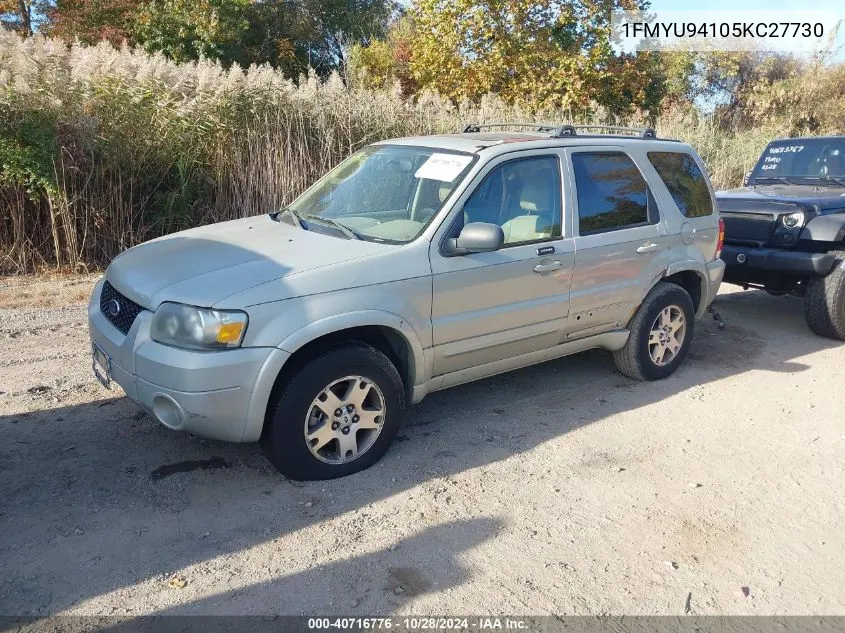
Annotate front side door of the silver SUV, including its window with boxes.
[431,150,575,376]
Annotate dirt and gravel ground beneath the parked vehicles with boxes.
[0,278,845,615]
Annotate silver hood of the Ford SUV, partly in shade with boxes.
[106,215,395,310]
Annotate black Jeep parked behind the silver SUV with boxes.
[716,136,845,341]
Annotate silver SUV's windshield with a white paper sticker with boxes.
[288,145,476,244]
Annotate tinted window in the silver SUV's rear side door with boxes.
[572,152,649,235]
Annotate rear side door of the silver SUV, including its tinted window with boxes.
[567,146,669,340]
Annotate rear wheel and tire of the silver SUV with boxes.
[613,282,695,380]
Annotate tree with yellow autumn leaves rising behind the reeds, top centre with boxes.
[411,0,662,113]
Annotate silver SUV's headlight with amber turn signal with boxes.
[150,303,248,349]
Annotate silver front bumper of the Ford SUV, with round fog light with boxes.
[88,281,290,442]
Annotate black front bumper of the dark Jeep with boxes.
[722,244,835,278]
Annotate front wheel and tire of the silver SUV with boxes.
[261,343,405,480]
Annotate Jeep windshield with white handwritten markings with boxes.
[750,137,845,186]
